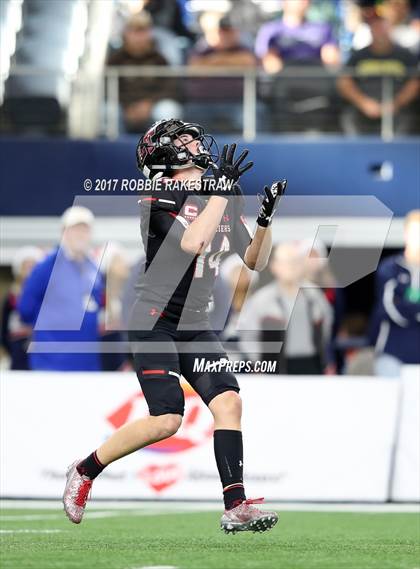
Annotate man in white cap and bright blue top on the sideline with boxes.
[18,206,103,371]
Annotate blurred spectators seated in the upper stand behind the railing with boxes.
[108,0,420,135]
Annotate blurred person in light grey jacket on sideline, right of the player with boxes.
[239,243,332,375]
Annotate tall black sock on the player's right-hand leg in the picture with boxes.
[214,429,245,510]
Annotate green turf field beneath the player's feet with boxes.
[0,509,420,569]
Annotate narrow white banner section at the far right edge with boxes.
[392,365,420,502]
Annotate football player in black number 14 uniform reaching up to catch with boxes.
[63,119,286,533]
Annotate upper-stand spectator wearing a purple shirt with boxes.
[255,0,340,73]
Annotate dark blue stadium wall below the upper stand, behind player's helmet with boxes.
[0,137,420,217]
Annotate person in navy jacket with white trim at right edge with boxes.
[372,210,420,377]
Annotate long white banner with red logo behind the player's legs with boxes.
[1,372,399,501]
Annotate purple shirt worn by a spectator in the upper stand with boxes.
[255,20,336,62]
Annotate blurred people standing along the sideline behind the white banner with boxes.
[1,206,420,377]
